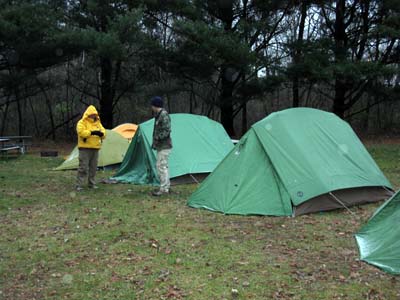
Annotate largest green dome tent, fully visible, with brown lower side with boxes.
[188,108,392,216]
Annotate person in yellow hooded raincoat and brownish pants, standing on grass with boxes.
[76,105,106,191]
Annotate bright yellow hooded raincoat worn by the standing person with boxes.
[76,105,106,149]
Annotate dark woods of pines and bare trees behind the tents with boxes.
[0,0,400,139]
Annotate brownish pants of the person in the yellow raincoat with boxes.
[76,149,99,187]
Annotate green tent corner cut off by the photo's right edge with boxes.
[355,191,400,274]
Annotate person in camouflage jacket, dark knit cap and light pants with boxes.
[151,96,172,196]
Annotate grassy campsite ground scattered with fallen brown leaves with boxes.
[0,143,400,299]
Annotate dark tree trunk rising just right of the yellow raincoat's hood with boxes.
[99,58,114,129]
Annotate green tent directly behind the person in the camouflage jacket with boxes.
[112,114,233,185]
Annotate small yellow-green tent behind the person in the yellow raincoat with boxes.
[55,129,129,170]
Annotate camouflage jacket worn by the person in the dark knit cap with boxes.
[151,109,172,151]
